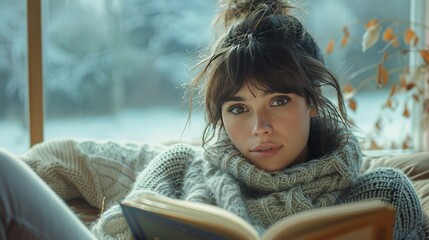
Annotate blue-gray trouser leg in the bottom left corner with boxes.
[0,148,94,240]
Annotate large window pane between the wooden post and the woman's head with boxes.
[44,0,216,142]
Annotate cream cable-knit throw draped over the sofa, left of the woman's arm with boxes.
[21,139,163,208]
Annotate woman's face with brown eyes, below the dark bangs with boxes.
[222,85,317,172]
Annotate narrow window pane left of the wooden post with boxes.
[0,0,30,153]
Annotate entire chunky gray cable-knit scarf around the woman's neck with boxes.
[198,129,362,232]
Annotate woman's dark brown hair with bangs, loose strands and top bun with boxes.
[189,0,348,155]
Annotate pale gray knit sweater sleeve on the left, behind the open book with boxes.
[91,144,195,239]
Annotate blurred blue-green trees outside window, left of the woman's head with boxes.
[0,0,215,118]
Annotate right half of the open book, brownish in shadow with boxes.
[264,200,395,240]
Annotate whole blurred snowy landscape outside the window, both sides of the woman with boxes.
[0,0,423,152]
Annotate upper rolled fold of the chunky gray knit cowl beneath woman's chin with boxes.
[205,128,362,191]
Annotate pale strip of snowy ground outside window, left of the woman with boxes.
[0,108,204,153]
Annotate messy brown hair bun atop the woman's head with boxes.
[215,0,294,27]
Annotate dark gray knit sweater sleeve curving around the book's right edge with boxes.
[342,168,424,240]
